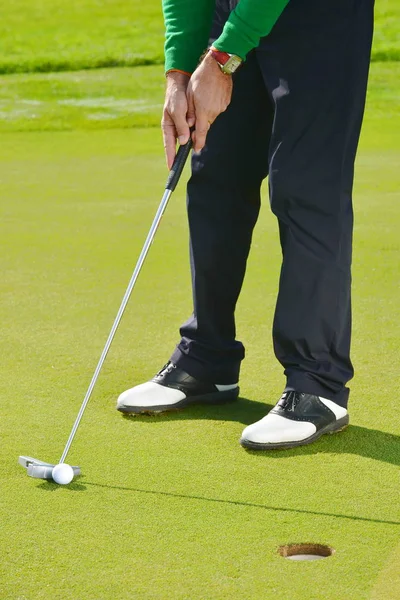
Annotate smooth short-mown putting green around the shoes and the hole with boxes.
[0,65,400,600]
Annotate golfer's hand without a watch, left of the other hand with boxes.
[161,71,190,169]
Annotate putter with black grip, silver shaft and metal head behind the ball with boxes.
[18,137,192,479]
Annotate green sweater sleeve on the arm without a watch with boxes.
[162,0,215,73]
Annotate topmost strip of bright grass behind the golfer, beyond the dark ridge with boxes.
[0,0,400,73]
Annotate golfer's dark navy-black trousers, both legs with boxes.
[172,0,373,406]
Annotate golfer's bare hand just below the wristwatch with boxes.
[187,55,233,152]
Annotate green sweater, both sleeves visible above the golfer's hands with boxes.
[162,0,289,73]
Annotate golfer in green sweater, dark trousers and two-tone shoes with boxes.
[118,0,373,450]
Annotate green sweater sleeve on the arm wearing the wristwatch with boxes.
[213,0,289,59]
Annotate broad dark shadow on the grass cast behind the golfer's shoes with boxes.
[124,398,400,465]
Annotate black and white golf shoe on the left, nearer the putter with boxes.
[117,362,239,414]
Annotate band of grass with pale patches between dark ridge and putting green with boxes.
[0,62,400,136]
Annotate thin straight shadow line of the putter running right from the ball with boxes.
[81,481,400,525]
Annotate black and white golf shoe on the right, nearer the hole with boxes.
[240,391,349,450]
